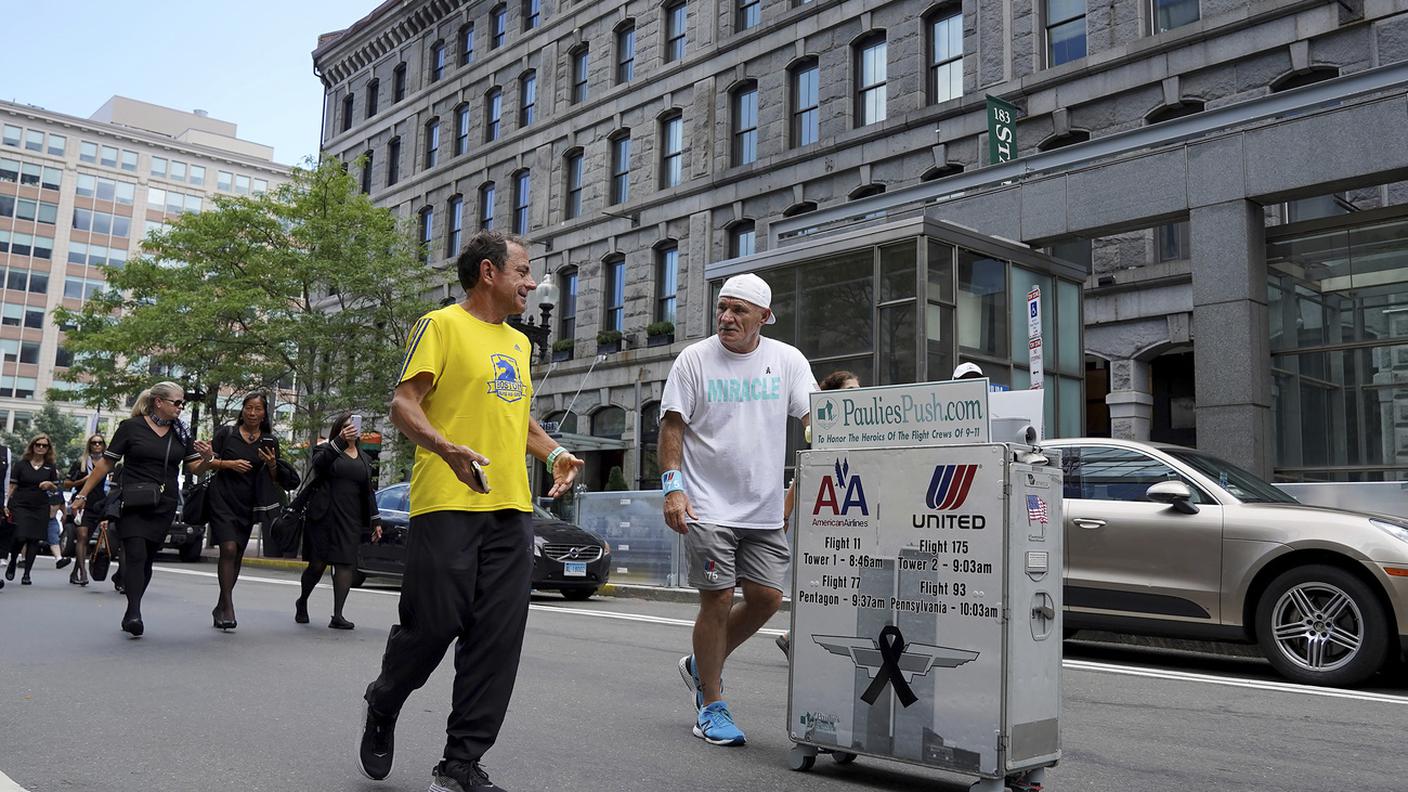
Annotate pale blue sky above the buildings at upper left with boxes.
[0,0,380,165]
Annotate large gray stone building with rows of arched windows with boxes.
[313,0,1408,486]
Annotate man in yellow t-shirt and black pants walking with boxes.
[358,231,582,792]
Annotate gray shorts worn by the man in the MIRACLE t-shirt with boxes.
[684,523,791,590]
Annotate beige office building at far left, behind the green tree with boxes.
[0,96,289,431]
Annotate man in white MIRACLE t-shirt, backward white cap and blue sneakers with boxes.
[660,273,817,745]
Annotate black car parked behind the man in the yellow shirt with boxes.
[356,483,611,599]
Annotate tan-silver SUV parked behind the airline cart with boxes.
[1046,438,1408,685]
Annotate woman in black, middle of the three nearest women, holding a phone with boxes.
[206,393,297,630]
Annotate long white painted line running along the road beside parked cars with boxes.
[151,567,1408,701]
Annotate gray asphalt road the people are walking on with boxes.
[0,559,1408,792]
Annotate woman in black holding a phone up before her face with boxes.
[293,413,382,630]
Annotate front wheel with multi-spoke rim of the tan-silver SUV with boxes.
[1256,565,1388,686]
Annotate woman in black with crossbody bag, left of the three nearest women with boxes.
[73,382,214,638]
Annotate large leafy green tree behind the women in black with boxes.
[55,158,442,470]
